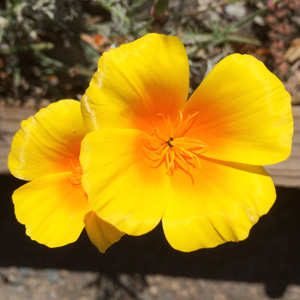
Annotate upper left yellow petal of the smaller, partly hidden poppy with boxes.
[8,100,86,181]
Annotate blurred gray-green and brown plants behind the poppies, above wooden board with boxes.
[0,0,300,105]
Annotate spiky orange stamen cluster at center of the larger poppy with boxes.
[143,112,207,181]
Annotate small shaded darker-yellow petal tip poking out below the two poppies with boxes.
[84,211,124,253]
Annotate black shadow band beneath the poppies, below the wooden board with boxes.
[0,176,300,298]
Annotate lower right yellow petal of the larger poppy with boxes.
[162,159,276,252]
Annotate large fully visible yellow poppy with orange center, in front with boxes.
[80,34,293,251]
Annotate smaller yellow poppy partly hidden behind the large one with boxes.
[8,100,123,252]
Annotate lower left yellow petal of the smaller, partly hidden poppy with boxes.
[12,172,90,248]
